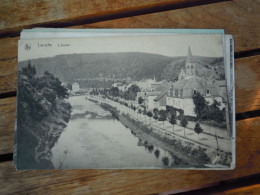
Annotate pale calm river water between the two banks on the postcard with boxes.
[52,96,173,169]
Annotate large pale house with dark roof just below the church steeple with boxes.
[166,76,225,116]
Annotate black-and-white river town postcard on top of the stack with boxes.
[15,34,234,169]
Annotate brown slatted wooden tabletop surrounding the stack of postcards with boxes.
[0,0,260,194]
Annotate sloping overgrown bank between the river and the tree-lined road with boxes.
[94,98,231,168]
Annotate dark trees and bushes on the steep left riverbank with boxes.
[17,62,71,168]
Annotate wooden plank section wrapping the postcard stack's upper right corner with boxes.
[74,0,260,52]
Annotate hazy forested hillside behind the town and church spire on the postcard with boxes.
[19,52,224,83]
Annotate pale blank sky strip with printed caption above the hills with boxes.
[18,34,223,61]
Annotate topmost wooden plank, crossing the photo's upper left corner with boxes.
[0,0,223,35]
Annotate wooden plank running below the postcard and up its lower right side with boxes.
[0,117,260,194]
